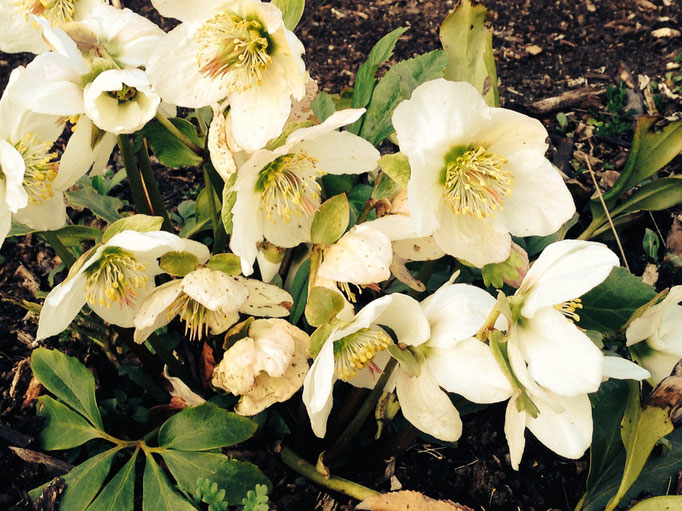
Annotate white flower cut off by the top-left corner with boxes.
[0,0,106,53]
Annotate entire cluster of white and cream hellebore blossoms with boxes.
[0,0,668,476]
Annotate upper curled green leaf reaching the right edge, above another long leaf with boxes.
[593,115,682,208]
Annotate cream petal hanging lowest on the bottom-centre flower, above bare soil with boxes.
[396,367,462,442]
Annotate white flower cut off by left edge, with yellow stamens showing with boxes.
[0,67,88,245]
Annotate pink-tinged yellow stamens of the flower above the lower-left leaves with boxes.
[85,247,149,308]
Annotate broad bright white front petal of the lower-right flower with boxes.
[510,307,604,396]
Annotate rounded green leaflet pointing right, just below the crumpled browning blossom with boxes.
[159,403,256,451]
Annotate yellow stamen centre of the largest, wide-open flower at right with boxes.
[442,146,514,218]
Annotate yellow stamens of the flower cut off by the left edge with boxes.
[14,133,59,205]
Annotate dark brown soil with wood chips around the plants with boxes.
[0,0,682,511]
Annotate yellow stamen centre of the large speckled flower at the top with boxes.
[196,11,274,92]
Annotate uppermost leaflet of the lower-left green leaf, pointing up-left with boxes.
[31,348,104,431]
